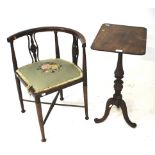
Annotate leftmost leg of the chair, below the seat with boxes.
[15,77,25,113]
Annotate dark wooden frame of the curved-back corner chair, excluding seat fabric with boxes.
[7,27,89,142]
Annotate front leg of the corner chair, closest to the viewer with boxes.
[35,97,46,142]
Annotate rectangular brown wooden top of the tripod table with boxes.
[91,24,147,55]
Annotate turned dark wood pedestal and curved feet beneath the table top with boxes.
[94,53,137,128]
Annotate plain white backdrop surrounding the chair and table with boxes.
[0,0,155,155]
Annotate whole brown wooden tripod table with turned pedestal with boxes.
[91,23,147,128]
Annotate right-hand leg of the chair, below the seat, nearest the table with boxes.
[83,85,89,120]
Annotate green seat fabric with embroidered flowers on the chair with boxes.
[16,59,83,93]
